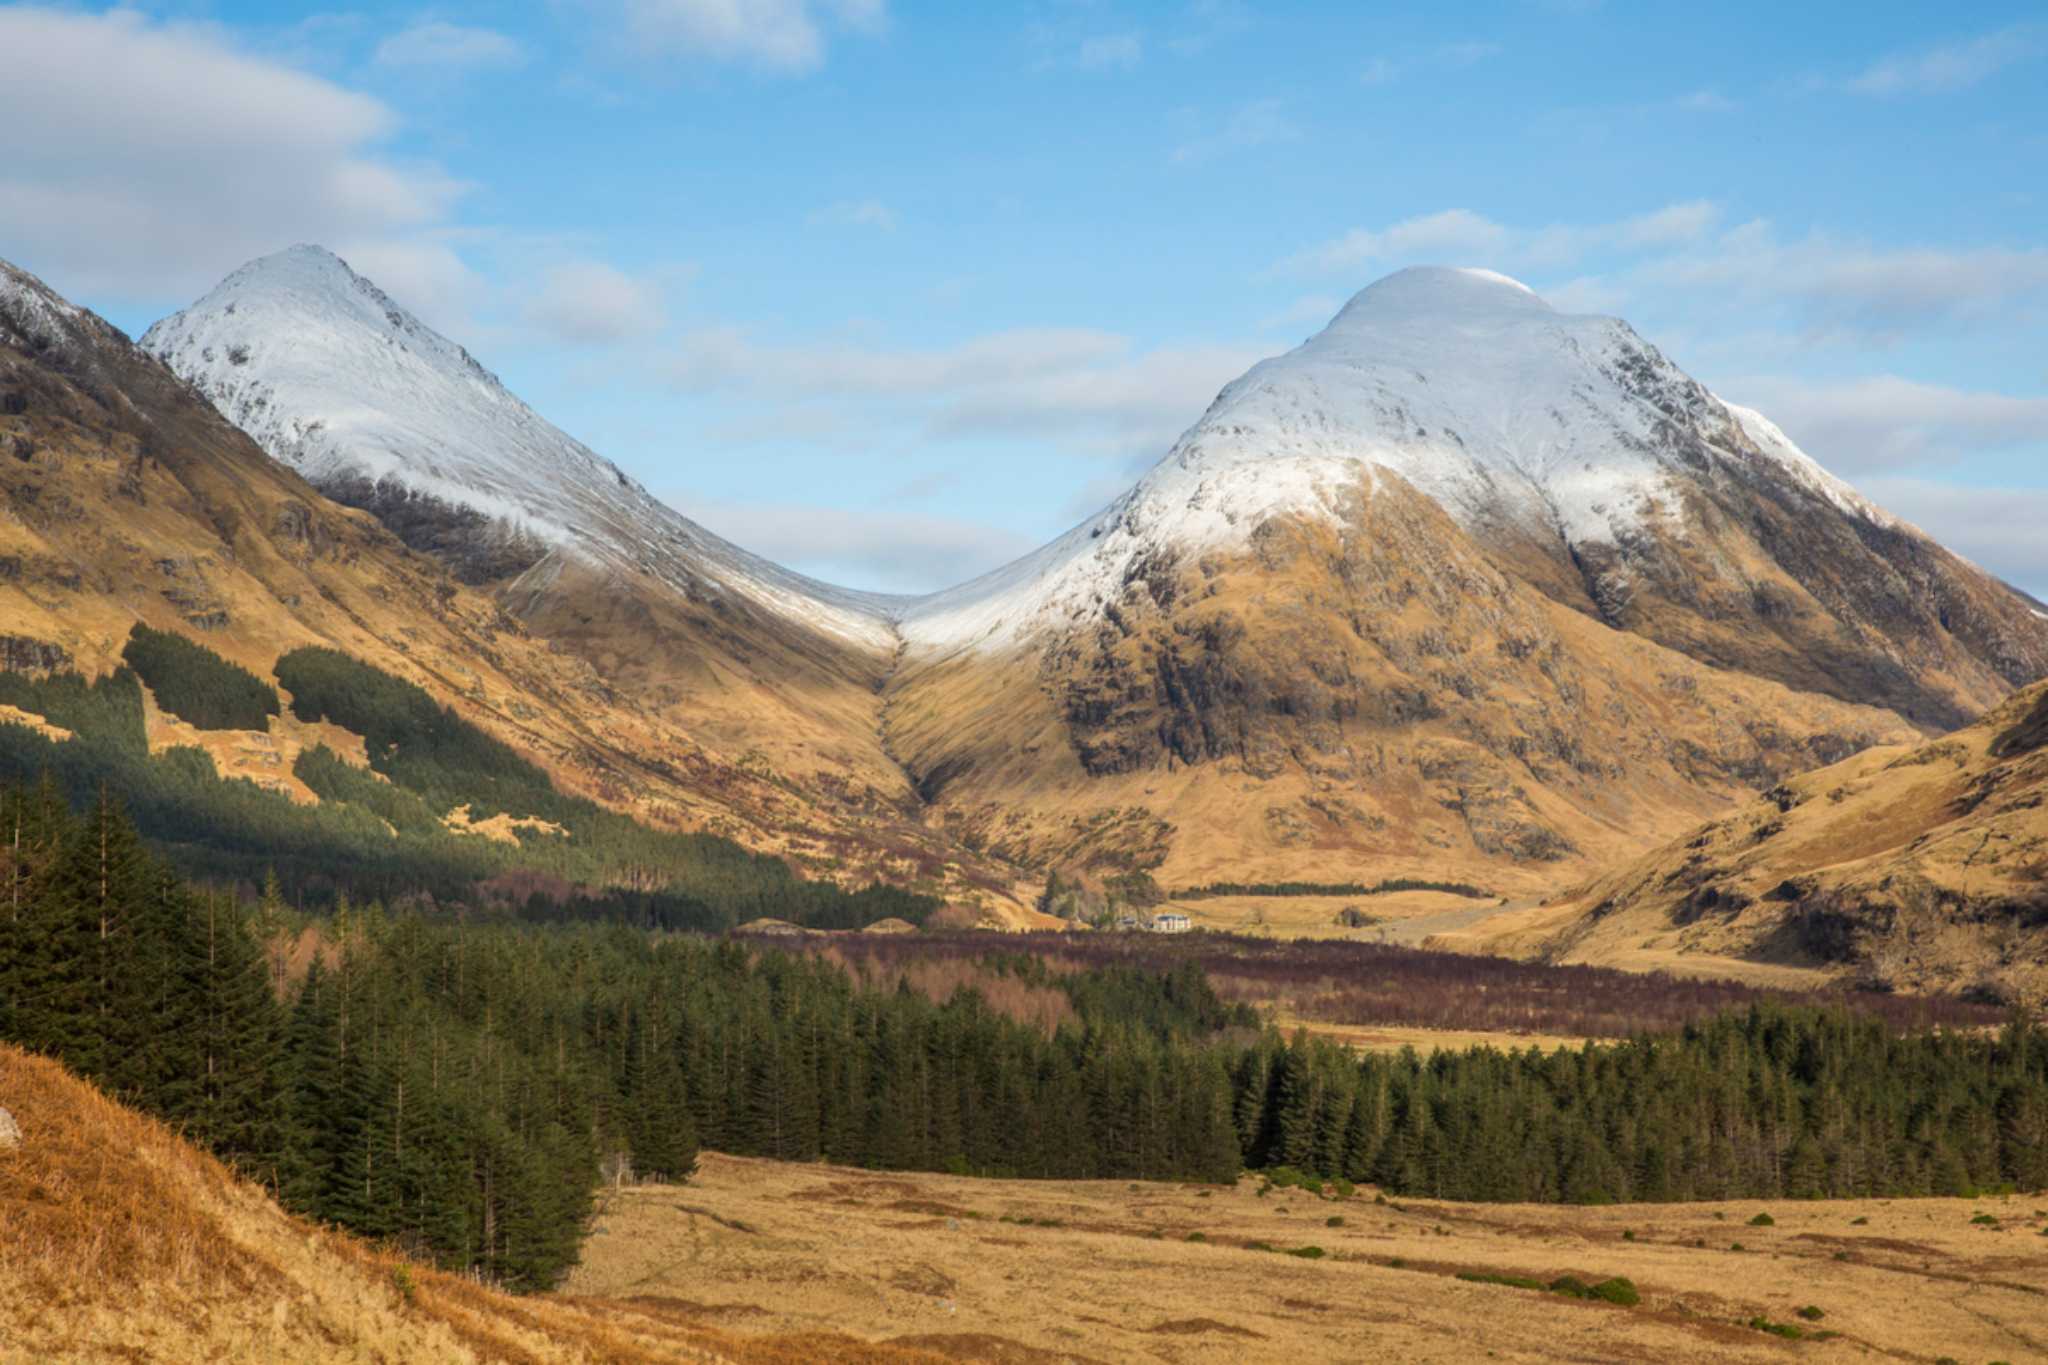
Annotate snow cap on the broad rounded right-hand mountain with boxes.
[903,268,1884,647]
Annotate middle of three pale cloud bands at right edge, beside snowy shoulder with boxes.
[1720,375,2048,475]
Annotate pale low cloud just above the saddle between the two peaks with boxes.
[668,493,1036,591]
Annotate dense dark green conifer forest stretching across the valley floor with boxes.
[0,784,2048,1289]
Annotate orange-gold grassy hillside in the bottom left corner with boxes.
[0,1046,938,1365]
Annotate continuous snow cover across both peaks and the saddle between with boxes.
[143,246,1949,671]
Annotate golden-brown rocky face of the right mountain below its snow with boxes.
[885,475,1917,894]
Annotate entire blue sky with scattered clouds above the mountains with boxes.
[0,0,2048,593]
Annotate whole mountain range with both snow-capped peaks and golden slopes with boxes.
[0,246,2048,990]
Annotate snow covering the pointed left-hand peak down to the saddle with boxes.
[141,246,895,649]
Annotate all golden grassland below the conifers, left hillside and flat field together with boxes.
[0,1046,2048,1365]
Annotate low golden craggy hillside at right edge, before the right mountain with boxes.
[1466,686,2048,1003]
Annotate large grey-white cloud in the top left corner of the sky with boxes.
[0,8,463,299]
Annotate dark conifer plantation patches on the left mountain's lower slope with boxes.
[0,642,940,931]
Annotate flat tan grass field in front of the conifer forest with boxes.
[565,1154,2048,1365]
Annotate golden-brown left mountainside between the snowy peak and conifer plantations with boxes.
[0,262,1012,902]
